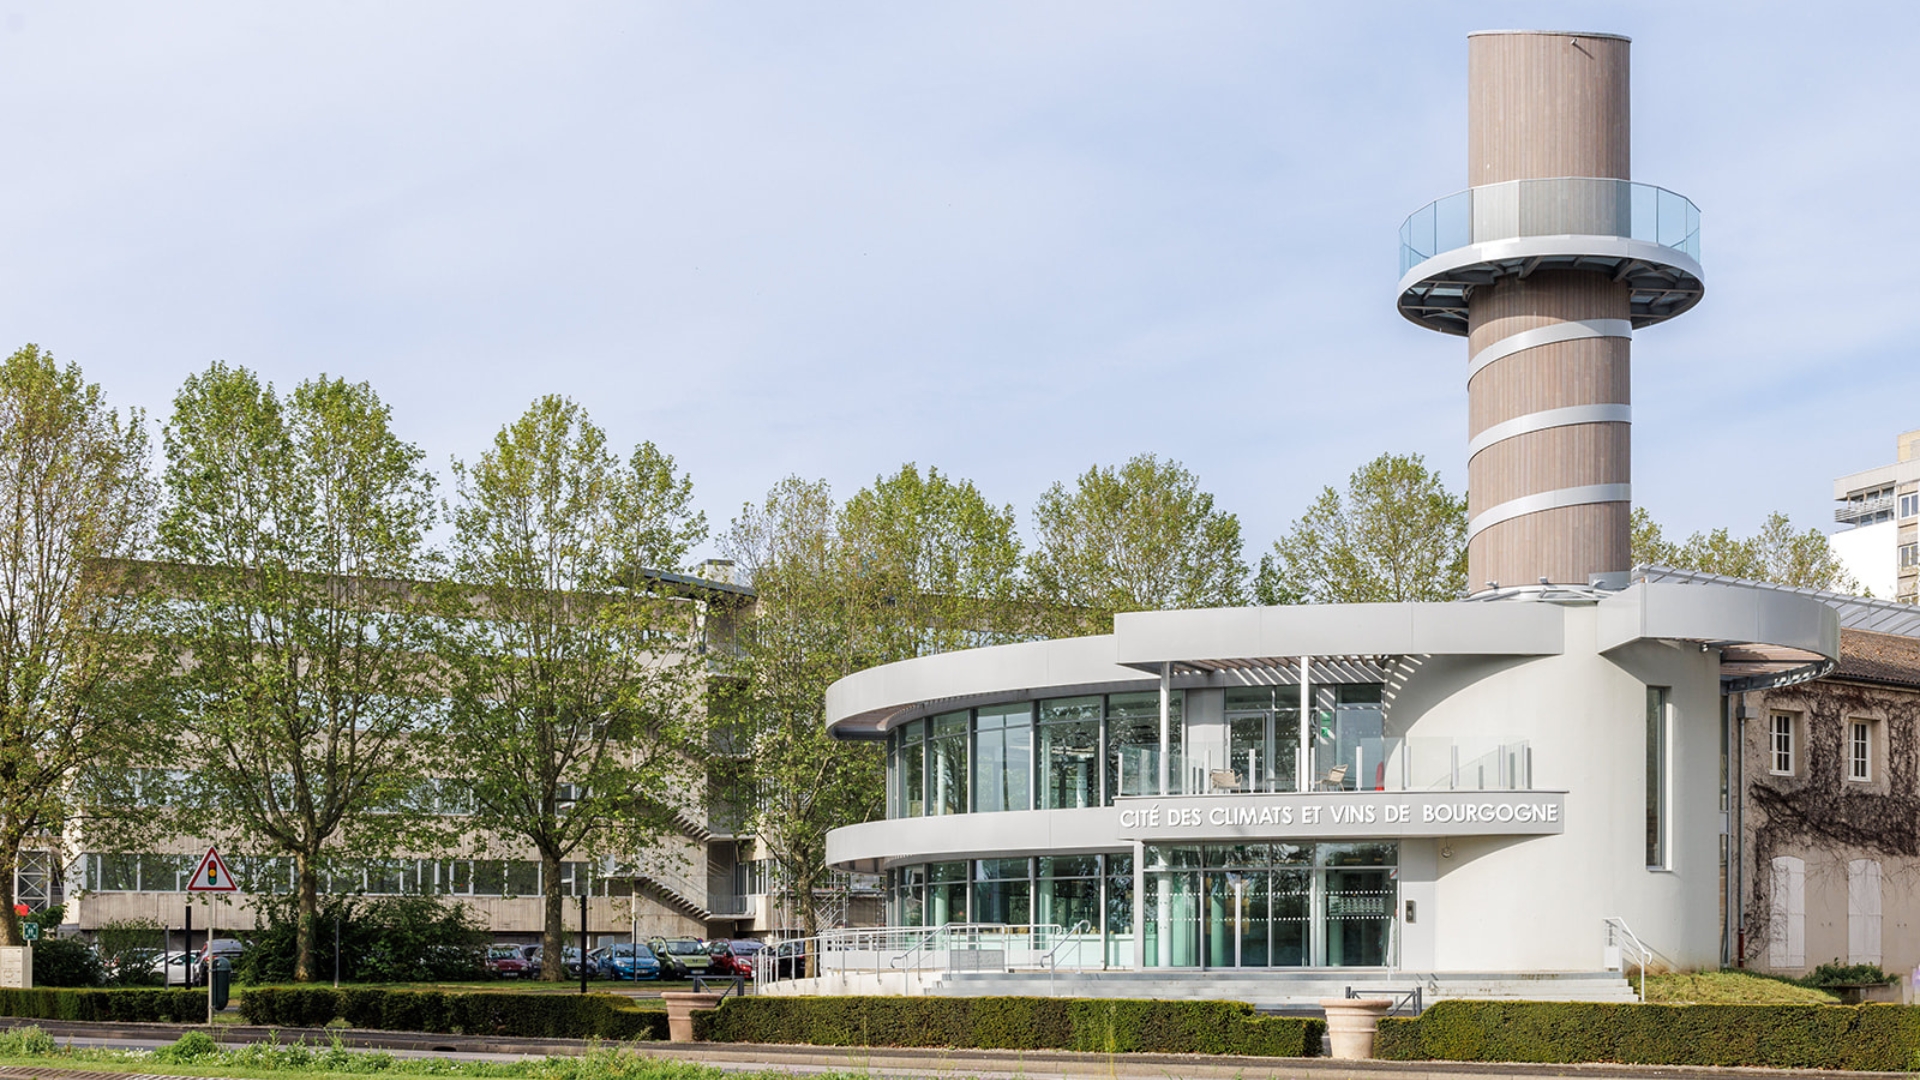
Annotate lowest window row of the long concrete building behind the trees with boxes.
[81,851,632,897]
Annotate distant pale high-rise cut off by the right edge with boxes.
[1832,430,1920,603]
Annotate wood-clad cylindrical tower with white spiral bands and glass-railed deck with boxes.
[1400,31,1705,592]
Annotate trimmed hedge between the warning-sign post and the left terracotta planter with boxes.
[240,986,666,1040]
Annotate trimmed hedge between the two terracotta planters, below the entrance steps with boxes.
[693,997,1327,1057]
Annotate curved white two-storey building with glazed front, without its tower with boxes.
[828,584,1839,972]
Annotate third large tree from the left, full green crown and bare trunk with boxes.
[449,396,707,980]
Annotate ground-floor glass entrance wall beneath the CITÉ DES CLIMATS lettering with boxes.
[1142,842,1400,969]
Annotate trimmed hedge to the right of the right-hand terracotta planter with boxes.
[1373,1001,1920,1072]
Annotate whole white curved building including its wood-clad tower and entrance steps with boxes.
[787,33,1839,1003]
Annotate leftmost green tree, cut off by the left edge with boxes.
[0,344,154,945]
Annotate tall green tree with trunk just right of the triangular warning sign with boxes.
[159,363,438,980]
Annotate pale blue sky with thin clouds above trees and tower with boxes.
[0,0,1920,555]
